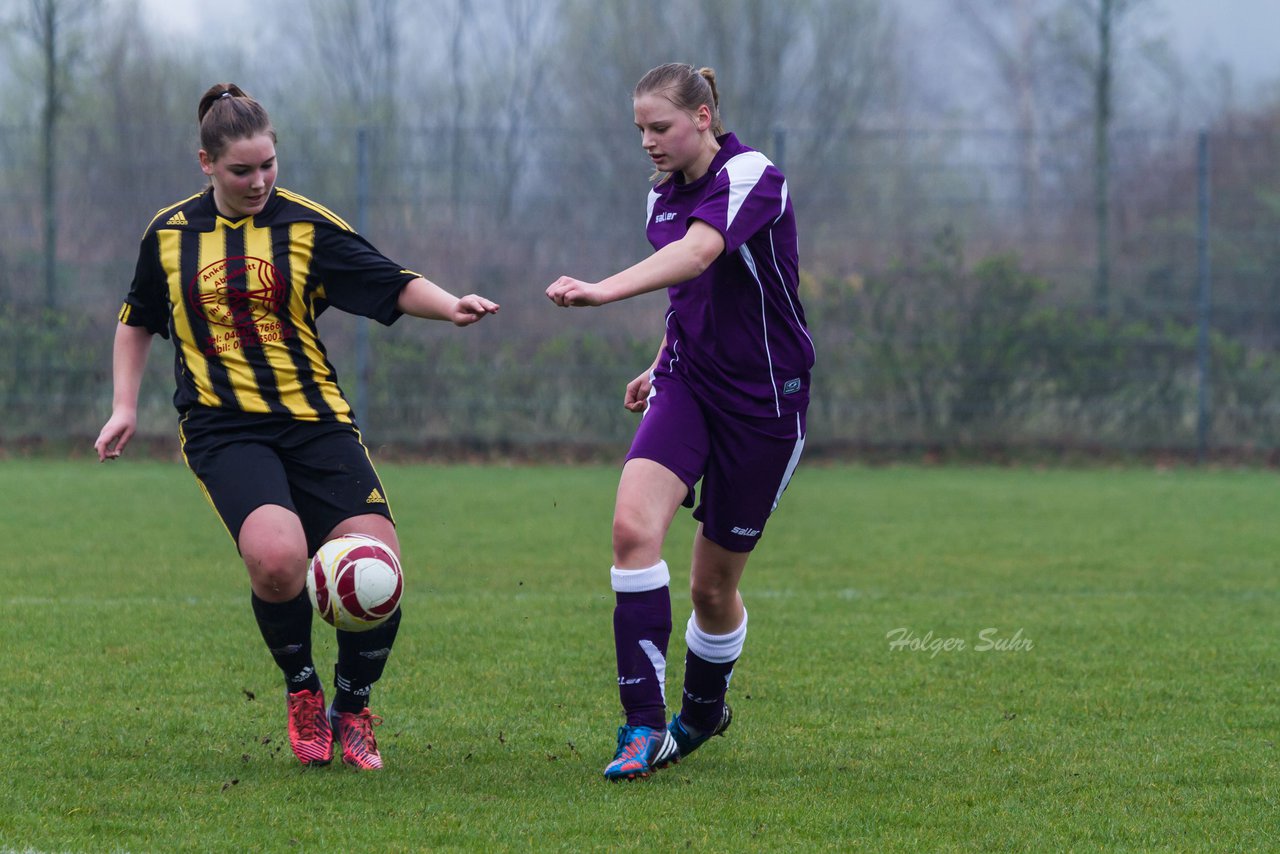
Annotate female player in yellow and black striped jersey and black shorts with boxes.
[95,83,498,769]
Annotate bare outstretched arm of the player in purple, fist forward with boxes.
[547,220,724,307]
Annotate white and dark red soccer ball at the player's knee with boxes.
[307,534,404,631]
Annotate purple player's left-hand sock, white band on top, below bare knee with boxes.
[612,561,671,730]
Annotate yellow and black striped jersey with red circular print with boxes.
[120,187,419,421]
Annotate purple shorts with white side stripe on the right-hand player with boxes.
[627,374,805,552]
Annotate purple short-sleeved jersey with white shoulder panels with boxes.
[646,133,814,417]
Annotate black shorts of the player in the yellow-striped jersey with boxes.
[178,406,396,554]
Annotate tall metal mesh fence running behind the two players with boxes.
[0,127,1280,456]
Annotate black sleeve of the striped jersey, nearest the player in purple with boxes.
[312,228,419,325]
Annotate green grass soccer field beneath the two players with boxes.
[0,461,1280,851]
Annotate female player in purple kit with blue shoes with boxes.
[547,63,814,780]
